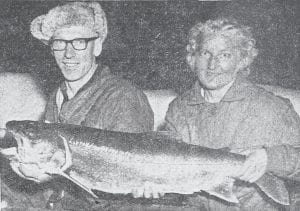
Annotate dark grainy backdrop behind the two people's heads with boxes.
[0,0,300,94]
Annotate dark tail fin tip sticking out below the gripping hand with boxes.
[255,173,290,205]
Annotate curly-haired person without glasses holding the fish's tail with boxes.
[166,18,300,210]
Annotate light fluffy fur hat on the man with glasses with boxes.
[30,2,107,44]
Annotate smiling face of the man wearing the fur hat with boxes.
[52,26,98,81]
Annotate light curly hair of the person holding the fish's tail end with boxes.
[187,18,258,74]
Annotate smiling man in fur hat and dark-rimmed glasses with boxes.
[5,2,153,210]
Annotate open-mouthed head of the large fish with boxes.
[0,121,66,182]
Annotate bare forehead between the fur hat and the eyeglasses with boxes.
[52,26,98,40]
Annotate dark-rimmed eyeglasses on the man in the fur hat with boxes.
[49,37,98,51]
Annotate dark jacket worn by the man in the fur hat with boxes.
[45,66,154,132]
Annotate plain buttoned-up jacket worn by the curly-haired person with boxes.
[166,77,300,210]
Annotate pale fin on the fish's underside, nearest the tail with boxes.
[205,177,239,203]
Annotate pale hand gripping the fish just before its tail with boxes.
[238,148,268,183]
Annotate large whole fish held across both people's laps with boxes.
[0,121,289,205]
